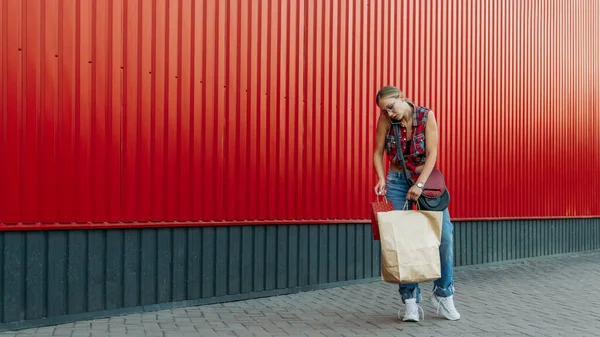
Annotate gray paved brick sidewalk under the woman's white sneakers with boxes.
[0,253,600,337]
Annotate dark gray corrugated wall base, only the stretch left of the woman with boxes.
[0,224,380,323]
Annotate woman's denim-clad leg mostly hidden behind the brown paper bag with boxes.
[386,170,421,303]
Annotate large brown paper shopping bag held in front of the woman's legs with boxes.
[377,210,443,283]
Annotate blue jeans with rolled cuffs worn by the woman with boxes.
[386,170,454,303]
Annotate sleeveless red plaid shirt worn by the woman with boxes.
[385,105,429,172]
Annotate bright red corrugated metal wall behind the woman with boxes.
[0,0,600,227]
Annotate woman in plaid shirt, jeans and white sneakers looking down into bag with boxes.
[373,86,460,322]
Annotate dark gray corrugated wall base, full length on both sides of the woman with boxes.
[0,219,600,330]
